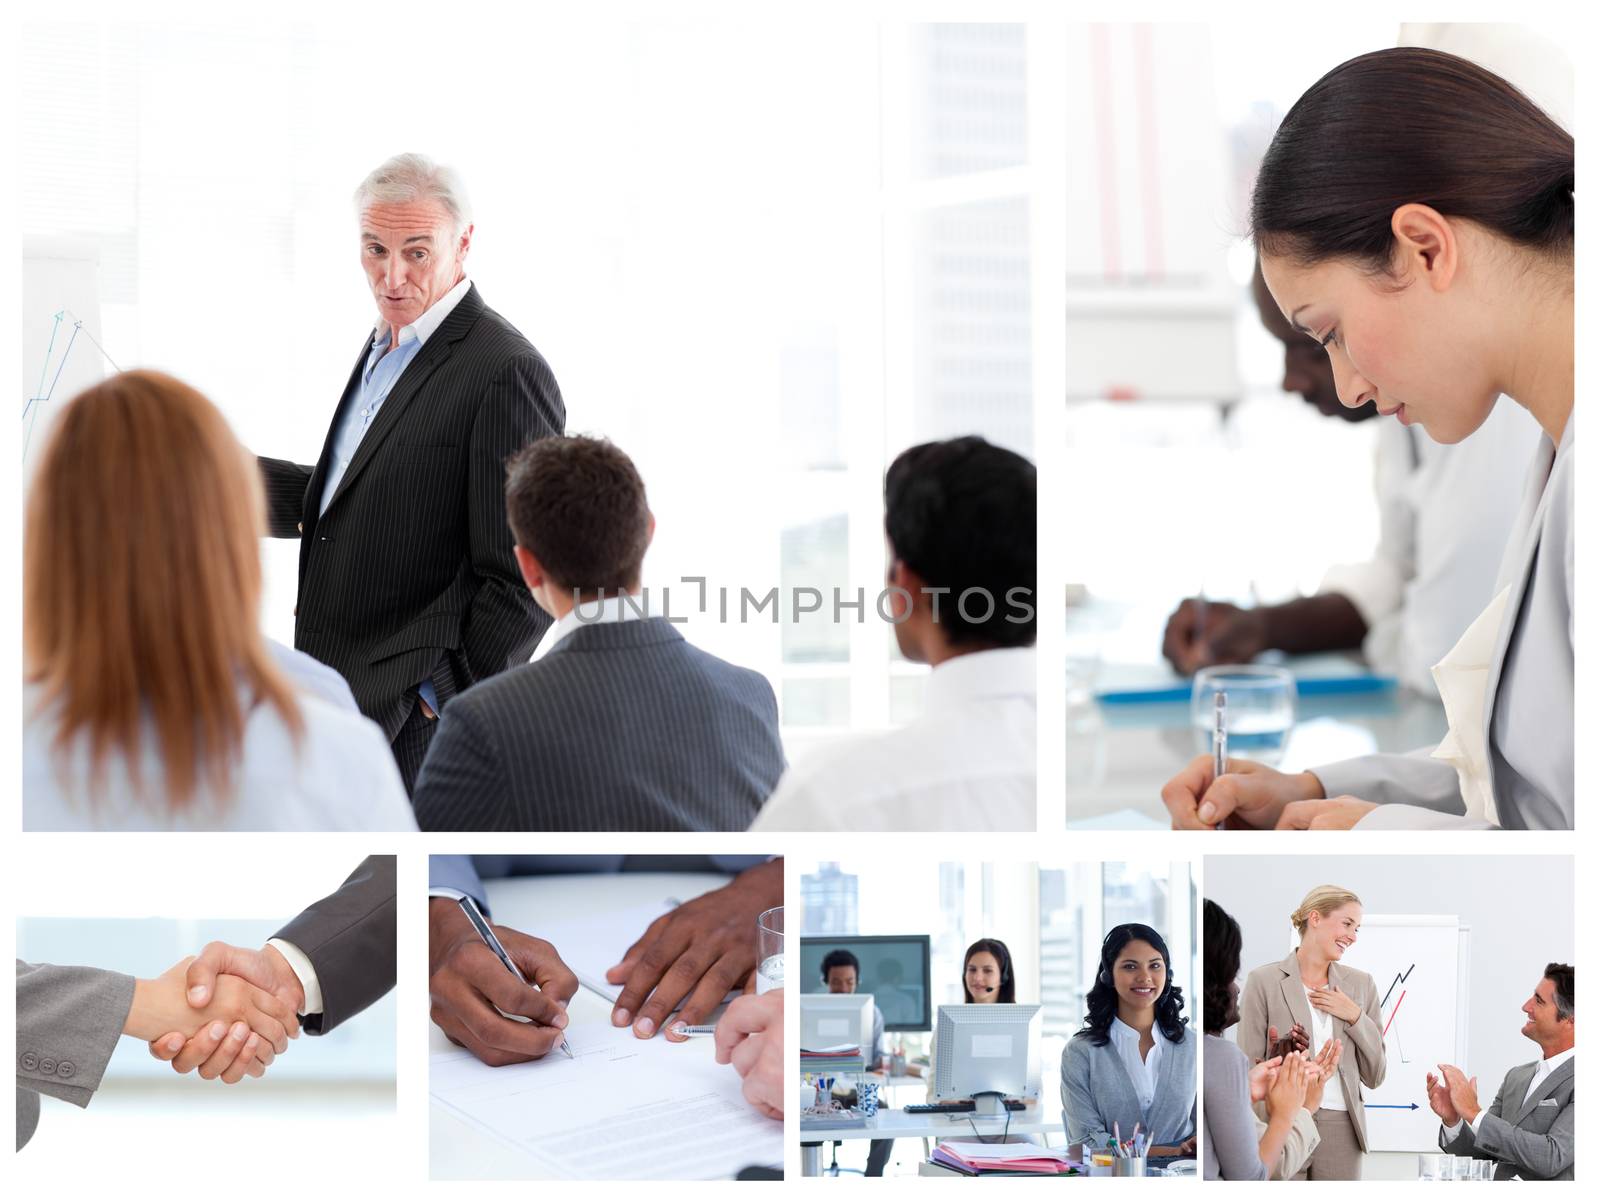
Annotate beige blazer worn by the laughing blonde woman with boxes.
[1237,950,1386,1152]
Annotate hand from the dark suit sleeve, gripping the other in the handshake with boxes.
[150,942,306,1083]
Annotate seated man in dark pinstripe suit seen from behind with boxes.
[414,437,784,830]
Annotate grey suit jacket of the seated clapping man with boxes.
[1438,1059,1578,1179]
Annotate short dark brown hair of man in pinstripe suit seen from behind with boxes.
[506,437,650,594]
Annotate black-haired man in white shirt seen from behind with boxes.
[750,437,1038,832]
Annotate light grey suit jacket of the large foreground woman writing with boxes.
[1315,419,1578,829]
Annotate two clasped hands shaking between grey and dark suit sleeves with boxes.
[122,942,306,1083]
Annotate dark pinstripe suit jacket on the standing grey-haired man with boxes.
[261,285,566,741]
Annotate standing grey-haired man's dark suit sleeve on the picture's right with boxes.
[454,354,566,704]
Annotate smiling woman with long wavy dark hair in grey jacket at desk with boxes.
[1061,925,1195,1158]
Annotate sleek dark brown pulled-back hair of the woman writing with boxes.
[1250,46,1573,272]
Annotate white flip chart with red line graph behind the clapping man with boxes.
[1290,912,1472,1154]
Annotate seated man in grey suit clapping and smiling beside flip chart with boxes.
[1427,963,1578,1179]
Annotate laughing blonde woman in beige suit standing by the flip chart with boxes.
[1238,885,1386,1179]
